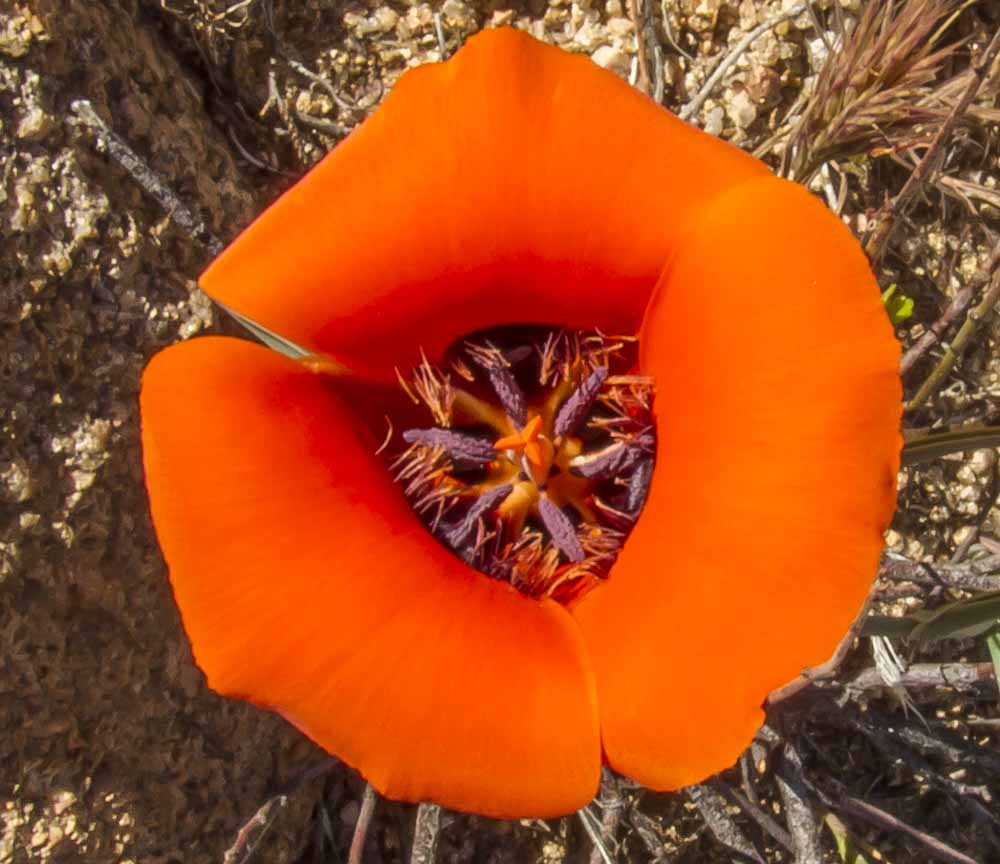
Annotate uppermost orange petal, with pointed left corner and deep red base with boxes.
[201,29,767,378]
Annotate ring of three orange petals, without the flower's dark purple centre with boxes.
[142,30,900,817]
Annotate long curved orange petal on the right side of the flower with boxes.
[574,178,901,789]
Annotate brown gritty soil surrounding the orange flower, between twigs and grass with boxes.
[0,0,1000,864]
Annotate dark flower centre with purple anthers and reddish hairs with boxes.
[392,327,656,603]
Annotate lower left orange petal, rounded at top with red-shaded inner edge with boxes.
[141,338,600,817]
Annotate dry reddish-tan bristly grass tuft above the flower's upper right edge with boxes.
[781,0,960,183]
